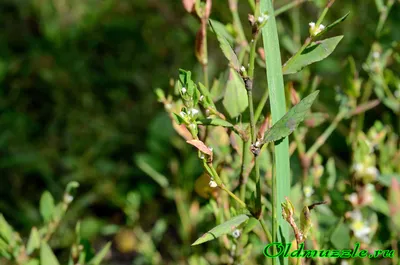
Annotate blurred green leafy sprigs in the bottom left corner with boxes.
[0,182,111,265]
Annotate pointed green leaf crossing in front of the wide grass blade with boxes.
[263,90,319,143]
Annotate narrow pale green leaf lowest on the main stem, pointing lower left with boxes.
[192,214,249,246]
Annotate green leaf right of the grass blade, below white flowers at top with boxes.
[283,36,343,75]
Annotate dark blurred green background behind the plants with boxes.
[0,0,400,264]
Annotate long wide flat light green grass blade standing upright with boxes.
[260,0,290,265]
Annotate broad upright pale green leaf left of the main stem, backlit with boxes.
[222,69,249,118]
